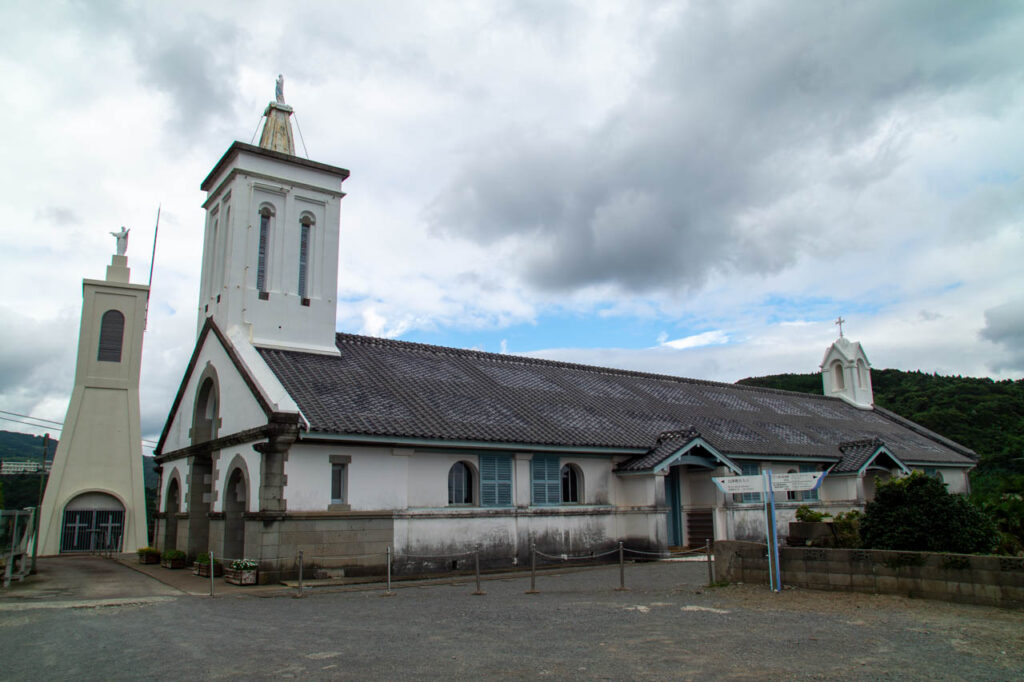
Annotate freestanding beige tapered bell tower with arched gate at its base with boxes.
[39,236,150,555]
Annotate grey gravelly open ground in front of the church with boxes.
[0,563,1024,680]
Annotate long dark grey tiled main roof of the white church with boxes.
[259,334,973,465]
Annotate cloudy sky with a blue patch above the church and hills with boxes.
[0,0,1024,450]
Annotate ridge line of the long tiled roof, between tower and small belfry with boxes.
[335,332,846,404]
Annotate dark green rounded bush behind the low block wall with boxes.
[860,471,997,554]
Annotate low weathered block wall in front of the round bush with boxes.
[715,541,1024,608]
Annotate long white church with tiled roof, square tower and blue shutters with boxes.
[156,87,977,582]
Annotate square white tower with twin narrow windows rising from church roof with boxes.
[197,76,348,354]
